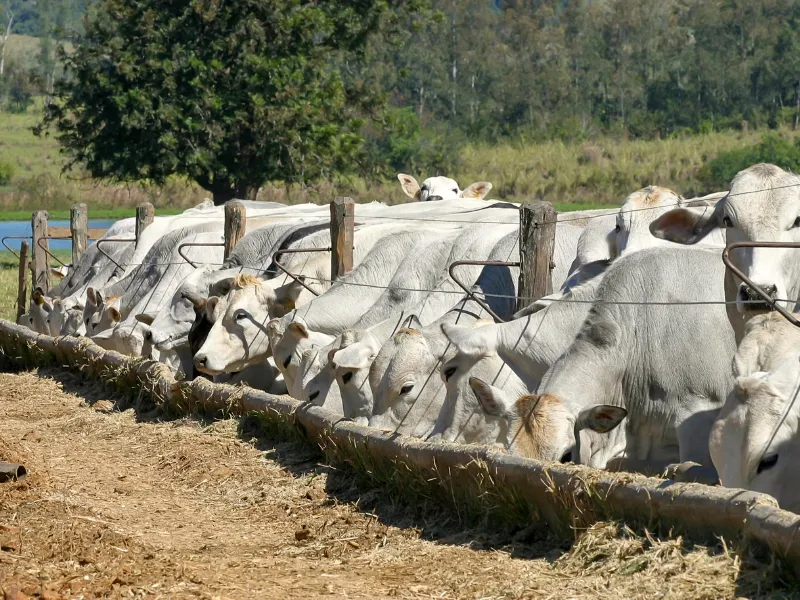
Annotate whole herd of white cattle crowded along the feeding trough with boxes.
[14,164,800,512]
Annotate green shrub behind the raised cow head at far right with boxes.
[697,133,800,190]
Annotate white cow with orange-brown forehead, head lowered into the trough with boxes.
[468,248,735,466]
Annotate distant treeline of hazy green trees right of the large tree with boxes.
[363,0,800,141]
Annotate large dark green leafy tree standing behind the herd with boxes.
[38,0,432,204]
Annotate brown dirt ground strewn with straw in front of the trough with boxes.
[0,371,792,600]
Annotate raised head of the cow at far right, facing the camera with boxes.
[650,164,800,326]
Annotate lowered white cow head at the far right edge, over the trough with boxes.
[709,352,800,512]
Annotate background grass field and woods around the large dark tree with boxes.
[0,0,800,214]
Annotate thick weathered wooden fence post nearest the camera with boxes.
[517,200,558,310]
